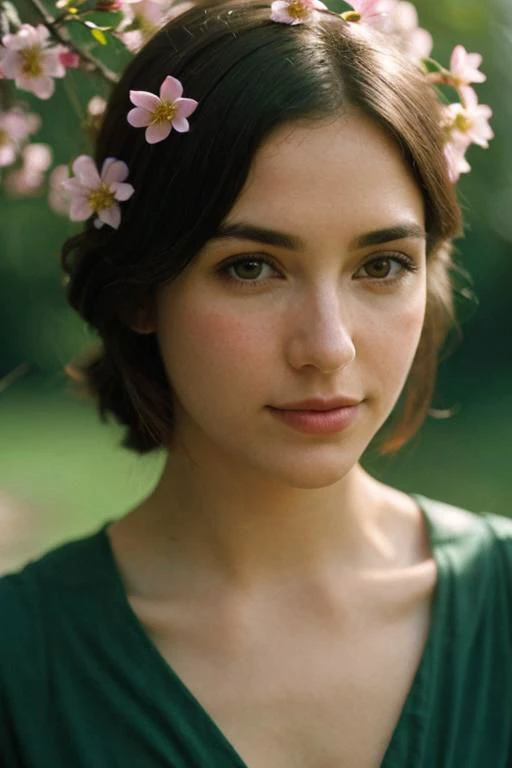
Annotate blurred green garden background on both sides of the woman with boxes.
[0,0,512,571]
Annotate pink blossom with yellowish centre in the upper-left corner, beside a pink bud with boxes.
[1,24,66,99]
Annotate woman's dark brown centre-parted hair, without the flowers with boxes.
[62,2,461,453]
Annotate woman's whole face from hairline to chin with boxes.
[156,112,426,488]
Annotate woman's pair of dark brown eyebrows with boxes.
[212,221,427,251]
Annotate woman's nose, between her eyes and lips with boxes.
[288,289,356,373]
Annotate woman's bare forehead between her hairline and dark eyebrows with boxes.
[226,113,424,240]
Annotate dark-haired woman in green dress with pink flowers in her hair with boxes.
[0,2,512,768]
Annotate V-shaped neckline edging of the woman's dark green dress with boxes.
[96,494,446,768]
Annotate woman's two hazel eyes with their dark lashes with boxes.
[216,252,419,287]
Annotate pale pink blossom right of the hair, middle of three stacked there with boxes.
[443,88,494,149]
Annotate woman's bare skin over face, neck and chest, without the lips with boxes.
[109,114,436,768]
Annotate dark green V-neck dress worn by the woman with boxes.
[0,496,512,768]
